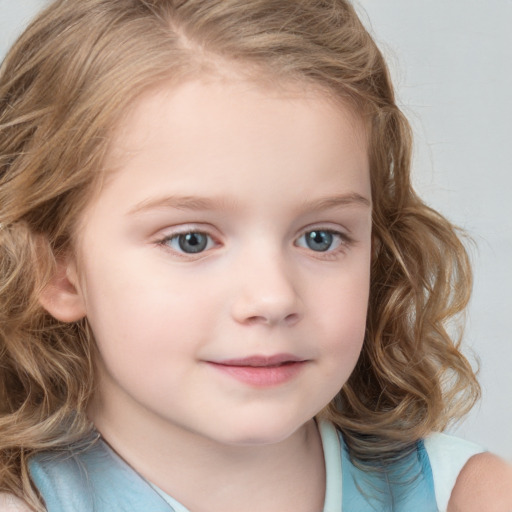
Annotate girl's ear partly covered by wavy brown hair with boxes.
[39,258,86,323]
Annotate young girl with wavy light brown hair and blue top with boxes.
[0,0,512,512]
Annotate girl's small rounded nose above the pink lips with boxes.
[231,249,303,326]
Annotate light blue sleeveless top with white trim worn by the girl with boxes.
[29,422,482,512]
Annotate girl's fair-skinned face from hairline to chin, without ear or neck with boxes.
[70,78,371,445]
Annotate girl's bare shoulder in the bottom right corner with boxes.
[448,453,512,512]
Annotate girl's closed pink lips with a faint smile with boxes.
[208,354,307,387]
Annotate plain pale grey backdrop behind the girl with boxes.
[0,0,512,462]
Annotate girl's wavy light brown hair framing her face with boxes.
[0,0,479,509]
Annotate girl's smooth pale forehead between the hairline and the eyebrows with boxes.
[86,76,370,217]
